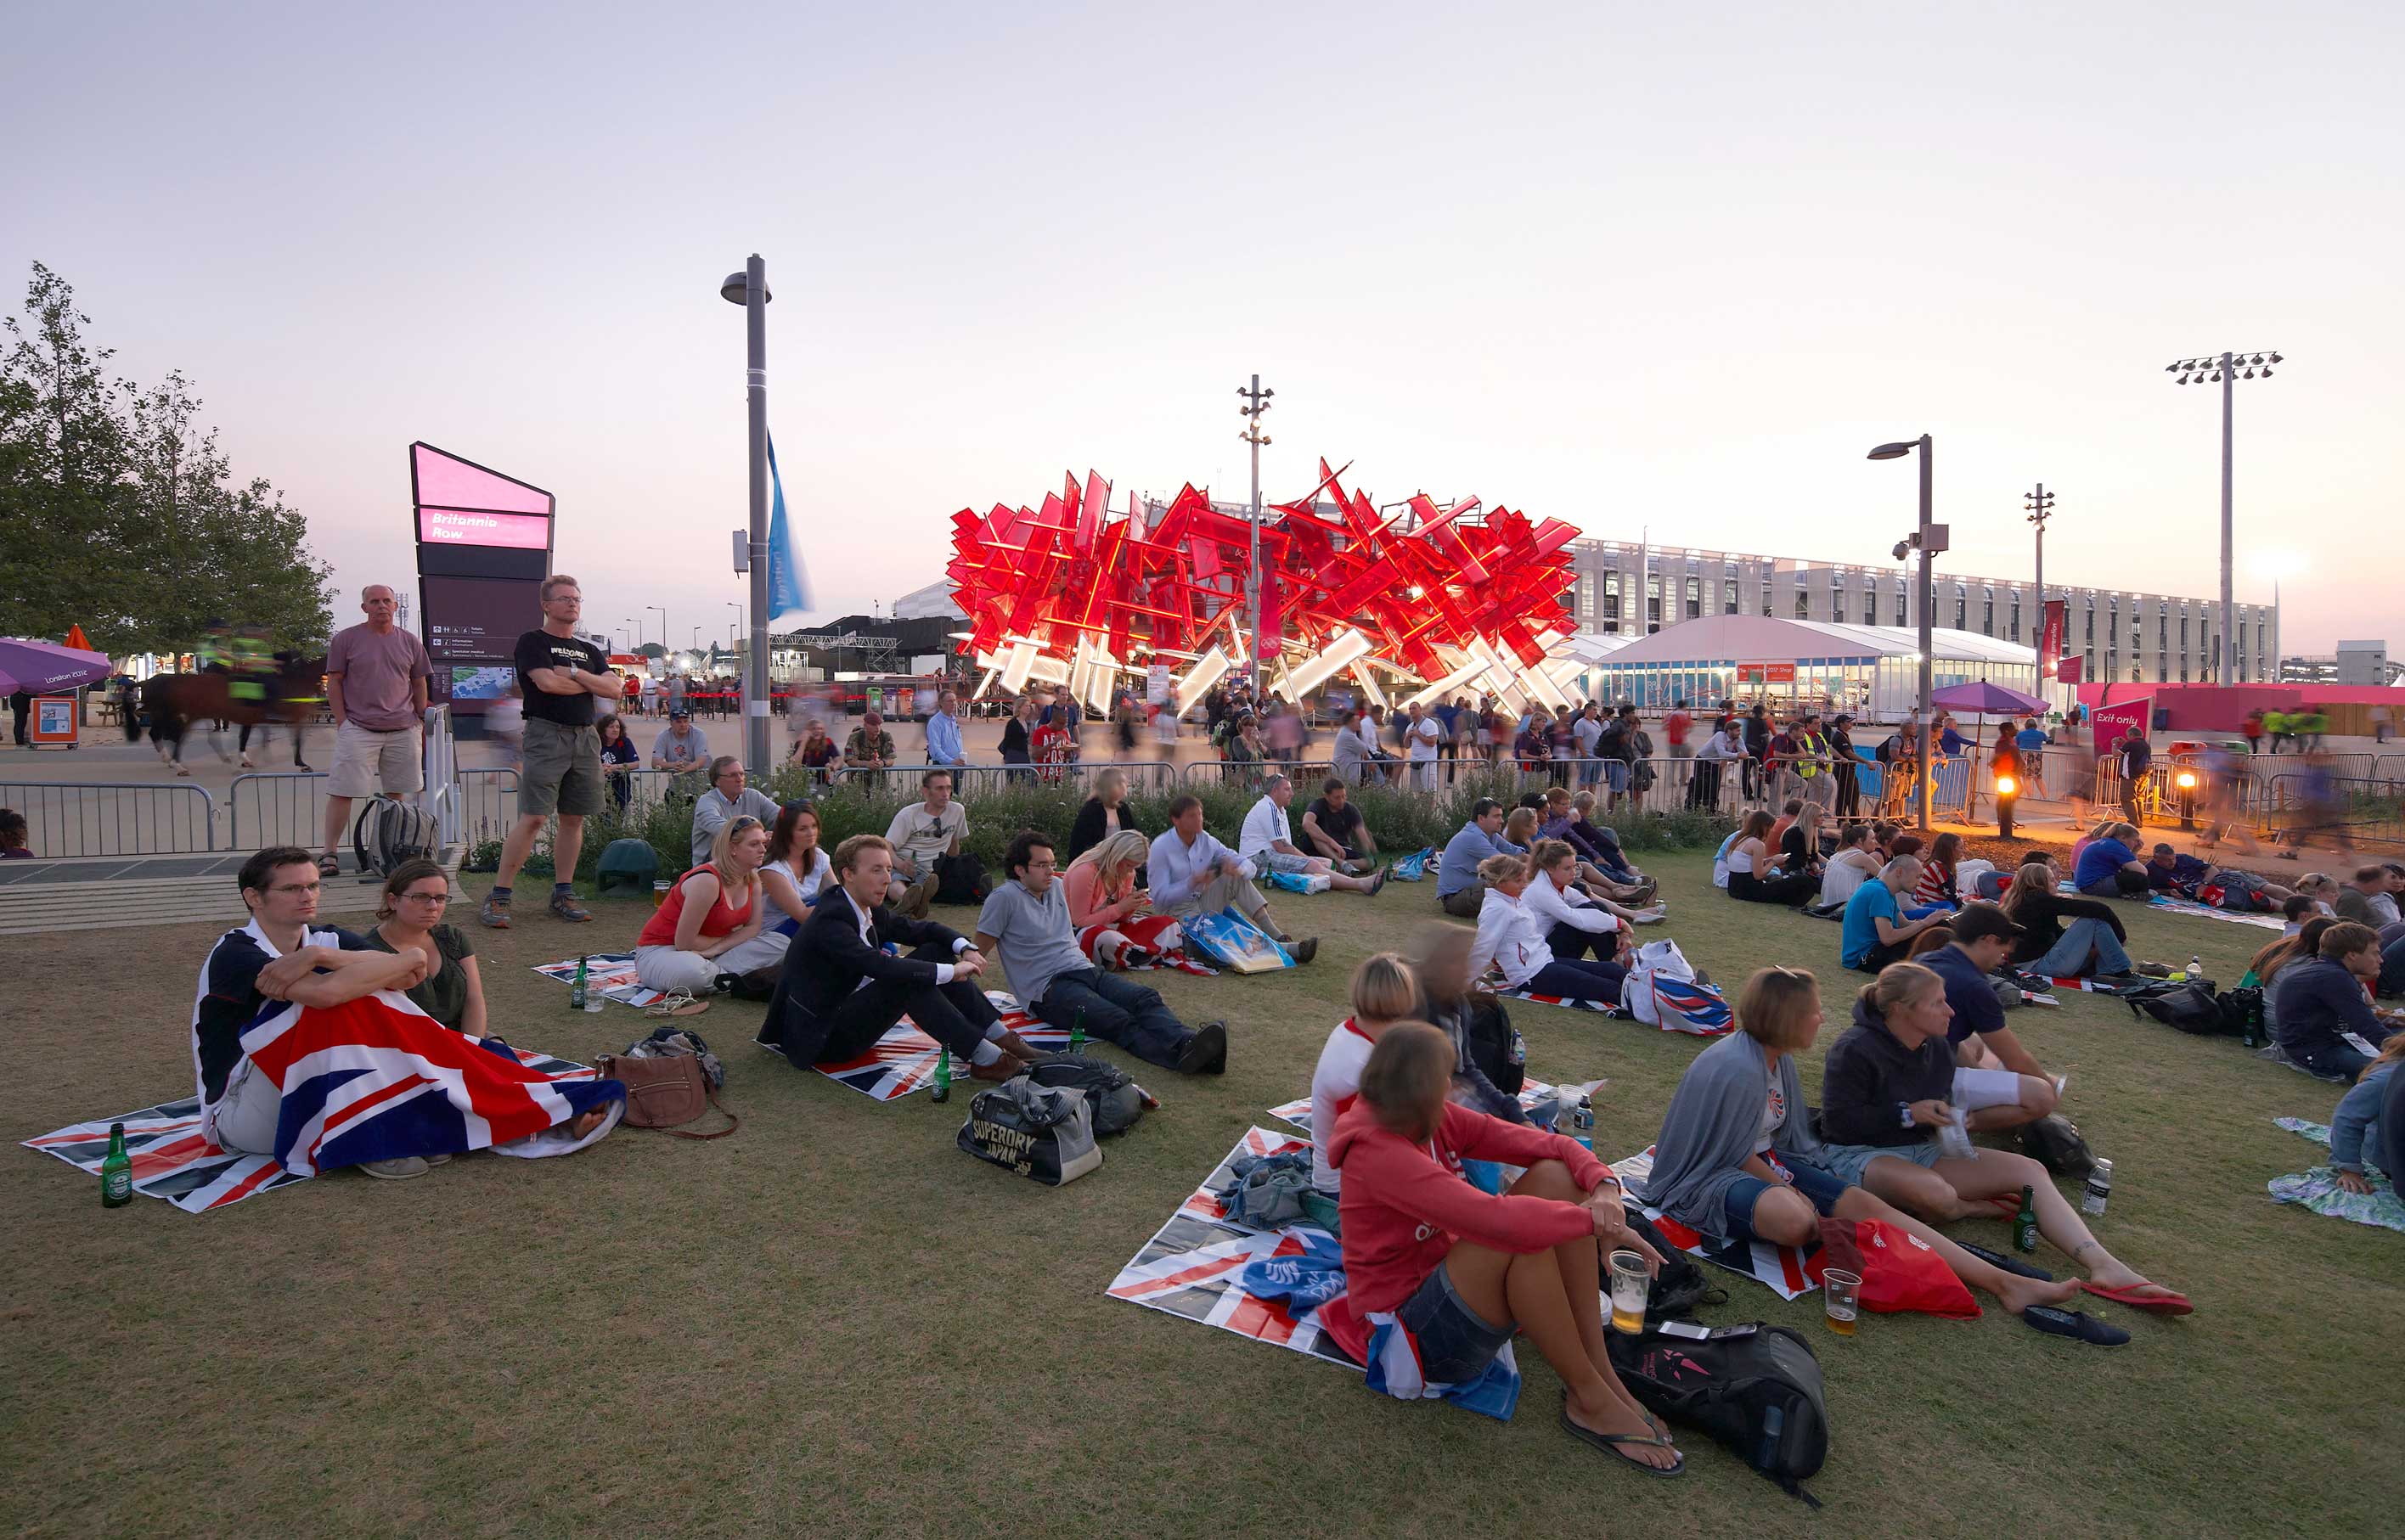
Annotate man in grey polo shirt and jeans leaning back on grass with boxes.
[977,829,1226,1074]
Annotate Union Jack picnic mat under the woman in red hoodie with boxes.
[1104,1124,1361,1374]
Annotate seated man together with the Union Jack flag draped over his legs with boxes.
[193,846,625,1177]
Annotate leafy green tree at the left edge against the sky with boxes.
[0,261,332,656]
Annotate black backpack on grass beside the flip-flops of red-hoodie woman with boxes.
[1604,1321,1828,1509]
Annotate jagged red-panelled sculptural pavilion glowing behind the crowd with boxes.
[945,461,1578,692]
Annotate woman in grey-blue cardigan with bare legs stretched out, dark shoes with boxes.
[1642,968,2078,1314]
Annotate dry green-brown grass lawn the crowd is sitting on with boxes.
[0,851,2405,1535]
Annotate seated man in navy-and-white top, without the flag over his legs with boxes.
[193,846,428,1177]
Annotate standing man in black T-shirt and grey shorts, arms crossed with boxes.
[476,572,625,930]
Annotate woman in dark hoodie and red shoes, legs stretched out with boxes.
[1821,964,2188,1314]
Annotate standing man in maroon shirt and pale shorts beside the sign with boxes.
[319,584,431,877]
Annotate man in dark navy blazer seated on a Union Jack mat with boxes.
[758,834,1046,1081]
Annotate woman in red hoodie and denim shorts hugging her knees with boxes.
[1321,1021,1686,1475]
